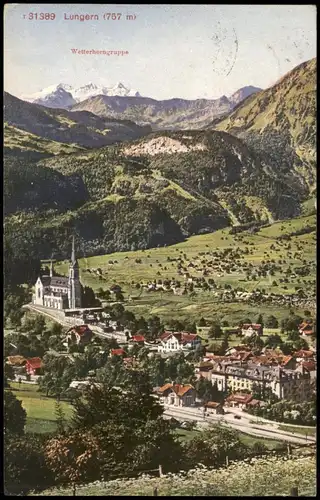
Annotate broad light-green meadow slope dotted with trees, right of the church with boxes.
[55,215,316,324]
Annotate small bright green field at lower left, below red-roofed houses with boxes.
[10,382,72,433]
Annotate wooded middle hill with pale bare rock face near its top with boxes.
[5,131,301,268]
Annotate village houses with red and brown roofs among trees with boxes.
[6,308,316,424]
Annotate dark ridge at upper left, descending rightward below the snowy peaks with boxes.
[4,92,151,148]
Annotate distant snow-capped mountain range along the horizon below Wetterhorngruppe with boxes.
[18,83,261,130]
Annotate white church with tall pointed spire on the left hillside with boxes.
[32,238,81,309]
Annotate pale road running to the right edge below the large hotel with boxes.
[165,405,316,444]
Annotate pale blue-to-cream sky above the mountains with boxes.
[4,4,316,99]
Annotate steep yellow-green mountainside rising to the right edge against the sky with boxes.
[212,59,316,193]
